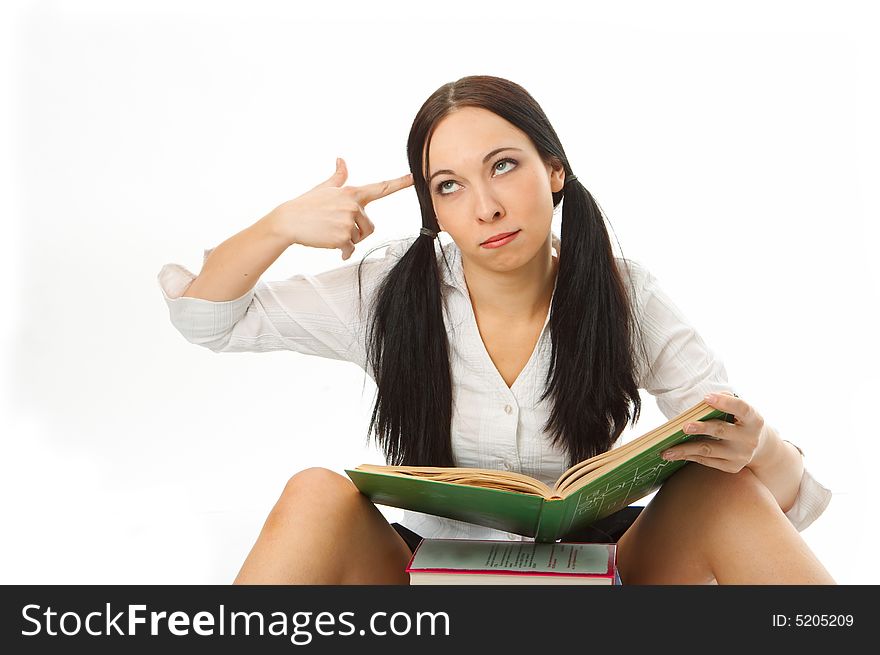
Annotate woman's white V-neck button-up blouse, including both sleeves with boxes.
[158,234,831,540]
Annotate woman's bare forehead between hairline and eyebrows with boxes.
[423,107,533,171]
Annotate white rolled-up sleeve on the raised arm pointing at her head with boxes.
[158,241,410,367]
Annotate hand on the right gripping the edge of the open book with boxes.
[661,392,770,473]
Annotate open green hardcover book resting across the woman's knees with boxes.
[345,402,734,541]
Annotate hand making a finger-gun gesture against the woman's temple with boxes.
[272,158,413,260]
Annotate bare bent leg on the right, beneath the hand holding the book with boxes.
[618,462,835,584]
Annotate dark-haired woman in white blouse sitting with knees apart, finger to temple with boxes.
[159,76,833,584]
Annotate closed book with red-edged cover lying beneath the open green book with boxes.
[406,539,620,585]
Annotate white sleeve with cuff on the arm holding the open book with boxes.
[627,262,832,531]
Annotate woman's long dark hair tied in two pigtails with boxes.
[358,75,641,466]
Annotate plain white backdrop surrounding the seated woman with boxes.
[0,0,880,584]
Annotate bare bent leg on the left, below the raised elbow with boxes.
[235,468,410,584]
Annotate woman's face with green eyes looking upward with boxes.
[425,107,565,271]
